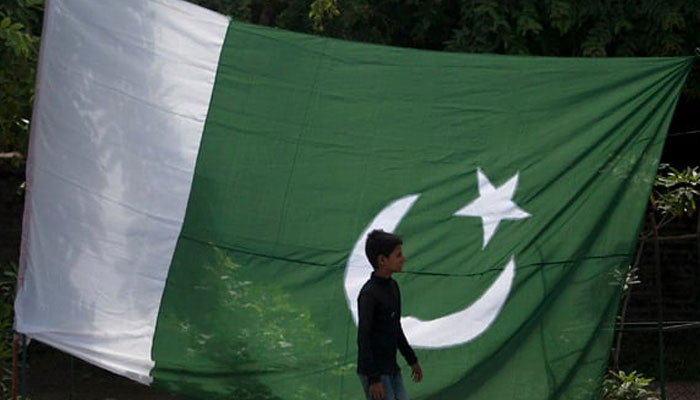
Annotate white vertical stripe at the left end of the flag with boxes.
[15,0,228,383]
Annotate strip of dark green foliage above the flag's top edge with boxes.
[185,0,700,98]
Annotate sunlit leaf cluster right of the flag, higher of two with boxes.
[652,164,700,217]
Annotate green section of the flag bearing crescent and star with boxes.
[152,22,692,400]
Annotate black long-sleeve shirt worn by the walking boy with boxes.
[357,274,418,384]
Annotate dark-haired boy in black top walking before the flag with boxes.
[357,230,423,400]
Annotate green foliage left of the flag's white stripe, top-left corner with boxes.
[0,0,44,162]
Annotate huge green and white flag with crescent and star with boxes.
[16,0,692,400]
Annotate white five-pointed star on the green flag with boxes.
[454,168,530,249]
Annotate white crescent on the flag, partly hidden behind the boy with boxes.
[345,194,515,349]
